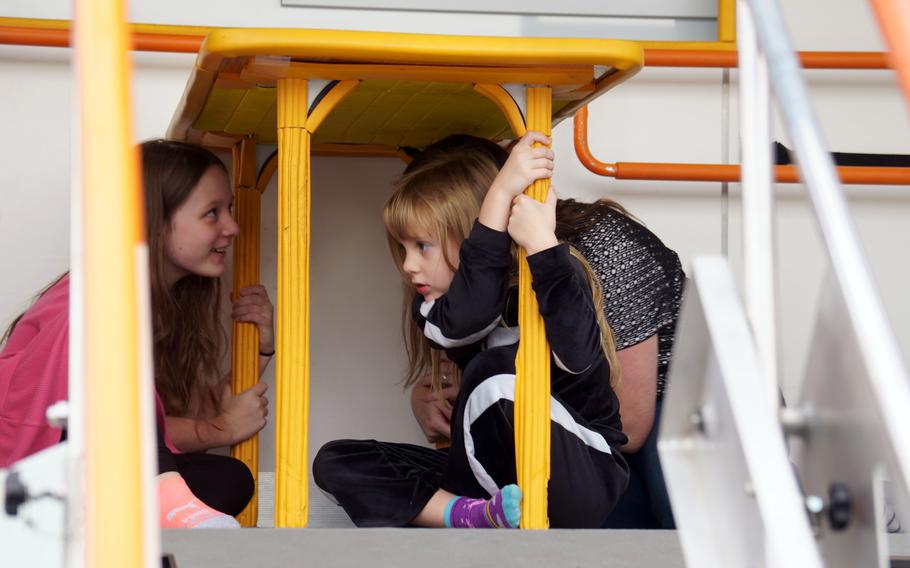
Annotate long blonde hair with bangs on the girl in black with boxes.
[383,141,620,392]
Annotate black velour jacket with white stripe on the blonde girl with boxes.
[412,222,626,446]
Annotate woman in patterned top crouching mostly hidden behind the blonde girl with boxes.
[405,134,686,529]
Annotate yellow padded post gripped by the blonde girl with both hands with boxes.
[515,87,553,529]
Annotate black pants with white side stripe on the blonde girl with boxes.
[313,345,629,528]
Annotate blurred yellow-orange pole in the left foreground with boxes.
[72,0,151,568]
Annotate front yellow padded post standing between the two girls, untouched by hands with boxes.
[275,79,310,527]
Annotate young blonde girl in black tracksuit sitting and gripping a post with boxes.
[314,133,628,528]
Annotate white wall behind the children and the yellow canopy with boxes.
[0,0,910,470]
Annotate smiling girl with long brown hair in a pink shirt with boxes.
[0,140,274,528]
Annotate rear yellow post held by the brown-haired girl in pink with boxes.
[231,138,261,527]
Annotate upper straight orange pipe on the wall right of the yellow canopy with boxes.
[645,49,889,69]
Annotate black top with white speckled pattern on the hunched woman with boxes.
[570,206,686,399]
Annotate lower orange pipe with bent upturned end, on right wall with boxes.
[575,106,910,185]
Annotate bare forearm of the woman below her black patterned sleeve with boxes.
[615,335,657,453]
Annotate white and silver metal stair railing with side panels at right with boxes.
[660,0,910,567]
